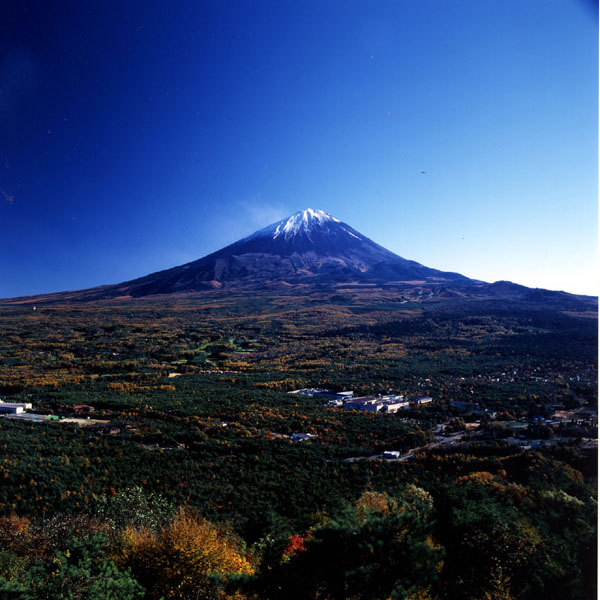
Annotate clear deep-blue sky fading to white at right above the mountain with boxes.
[0,0,598,297]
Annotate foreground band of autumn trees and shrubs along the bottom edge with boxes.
[0,448,596,600]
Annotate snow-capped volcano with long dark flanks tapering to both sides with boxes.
[3,208,596,302]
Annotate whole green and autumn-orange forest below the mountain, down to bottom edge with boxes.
[0,290,597,600]
